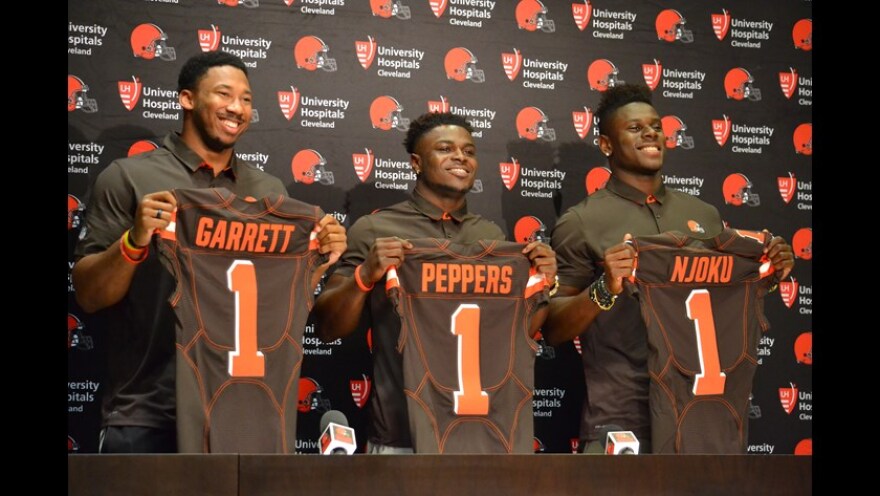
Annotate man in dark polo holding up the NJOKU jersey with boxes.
[542,85,794,452]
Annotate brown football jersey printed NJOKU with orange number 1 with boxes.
[630,229,773,453]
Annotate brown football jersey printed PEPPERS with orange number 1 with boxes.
[386,239,548,453]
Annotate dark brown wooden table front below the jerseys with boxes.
[67,454,813,496]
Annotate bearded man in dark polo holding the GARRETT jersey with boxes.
[73,52,345,453]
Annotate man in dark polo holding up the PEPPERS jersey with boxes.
[315,113,556,453]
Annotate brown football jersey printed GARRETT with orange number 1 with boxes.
[159,188,323,453]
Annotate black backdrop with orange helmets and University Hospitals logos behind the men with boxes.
[67,0,813,454]
